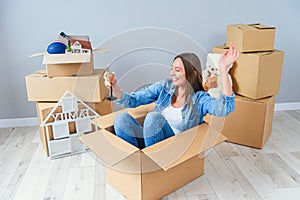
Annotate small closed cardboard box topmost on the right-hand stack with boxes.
[226,24,275,52]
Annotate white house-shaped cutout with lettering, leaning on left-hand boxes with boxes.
[41,90,99,158]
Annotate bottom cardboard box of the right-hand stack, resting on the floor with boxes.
[205,95,275,148]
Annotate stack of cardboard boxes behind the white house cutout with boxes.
[25,36,112,157]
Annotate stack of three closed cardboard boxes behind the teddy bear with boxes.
[212,24,284,148]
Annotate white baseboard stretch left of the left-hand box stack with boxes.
[0,117,38,128]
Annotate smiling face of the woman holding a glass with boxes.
[170,58,186,86]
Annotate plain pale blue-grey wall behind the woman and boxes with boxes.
[0,0,300,119]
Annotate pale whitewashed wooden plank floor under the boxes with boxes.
[0,110,300,200]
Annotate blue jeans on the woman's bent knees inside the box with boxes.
[114,112,175,149]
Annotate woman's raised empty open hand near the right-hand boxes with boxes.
[219,43,240,72]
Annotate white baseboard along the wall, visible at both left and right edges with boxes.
[0,102,300,128]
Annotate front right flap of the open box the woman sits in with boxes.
[142,123,226,170]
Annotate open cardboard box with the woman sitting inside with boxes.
[79,105,226,200]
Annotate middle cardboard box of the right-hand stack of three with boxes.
[212,46,284,99]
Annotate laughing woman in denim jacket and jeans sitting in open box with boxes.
[104,44,239,149]
